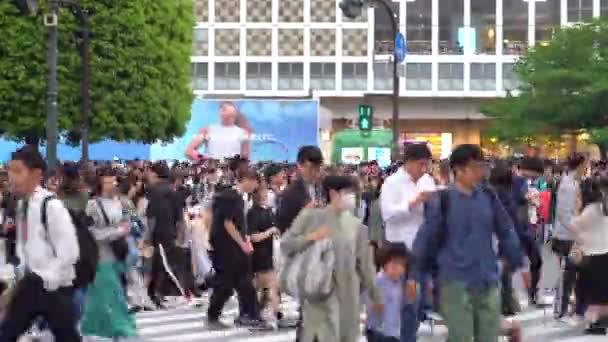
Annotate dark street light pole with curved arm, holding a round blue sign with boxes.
[340,0,400,160]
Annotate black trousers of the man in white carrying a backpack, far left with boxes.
[0,273,82,342]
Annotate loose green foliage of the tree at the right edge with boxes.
[482,19,608,142]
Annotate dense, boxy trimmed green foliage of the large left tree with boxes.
[0,0,194,143]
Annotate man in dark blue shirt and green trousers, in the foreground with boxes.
[414,144,522,342]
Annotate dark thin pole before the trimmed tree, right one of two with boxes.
[77,8,91,163]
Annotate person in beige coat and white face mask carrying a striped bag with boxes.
[281,176,382,342]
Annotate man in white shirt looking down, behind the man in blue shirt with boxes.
[380,144,436,342]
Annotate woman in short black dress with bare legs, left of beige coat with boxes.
[247,184,280,318]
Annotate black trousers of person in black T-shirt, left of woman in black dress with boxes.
[207,251,258,321]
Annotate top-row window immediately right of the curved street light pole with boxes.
[405,0,433,55]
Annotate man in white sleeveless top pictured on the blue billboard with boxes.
[186,102,253,160]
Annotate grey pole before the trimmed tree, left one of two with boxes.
[45,0,59,170]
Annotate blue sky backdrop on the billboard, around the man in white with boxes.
[0,100,319,162]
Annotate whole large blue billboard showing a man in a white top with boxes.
[0,100,319,162]
